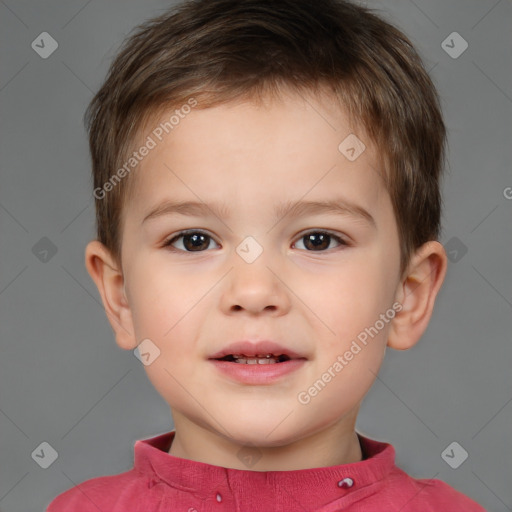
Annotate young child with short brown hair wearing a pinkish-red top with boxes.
[47,0,484,512]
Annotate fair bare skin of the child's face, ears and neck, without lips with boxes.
[86,87,447,471]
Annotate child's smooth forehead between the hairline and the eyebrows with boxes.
[128,89,384,220]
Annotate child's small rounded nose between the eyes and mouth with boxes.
[221,251,291,316]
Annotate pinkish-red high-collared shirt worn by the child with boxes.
[47,431,485,512]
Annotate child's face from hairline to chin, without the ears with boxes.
[117,90,400,462]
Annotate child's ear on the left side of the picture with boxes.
[85,240,137,350]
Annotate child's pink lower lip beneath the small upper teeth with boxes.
[210,359,306,384]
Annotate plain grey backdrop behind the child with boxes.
[0,0,512,512]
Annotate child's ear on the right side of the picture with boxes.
[388,241,447,350]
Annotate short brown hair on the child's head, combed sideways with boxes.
[86,0,446,272]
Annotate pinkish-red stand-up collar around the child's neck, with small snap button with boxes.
[134,431,395,508]
